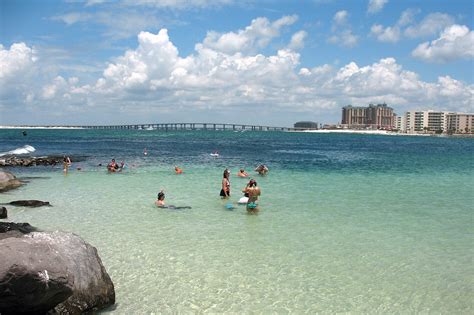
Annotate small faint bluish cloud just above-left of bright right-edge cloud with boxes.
[405,13,454,38]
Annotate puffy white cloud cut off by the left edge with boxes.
[0,43,37,79]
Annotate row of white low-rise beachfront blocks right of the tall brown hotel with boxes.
[397,110,473,133]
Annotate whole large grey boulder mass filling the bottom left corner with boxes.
[0,232,115,314]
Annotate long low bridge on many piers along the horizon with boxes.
[70,123,307,131]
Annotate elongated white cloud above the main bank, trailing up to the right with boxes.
[202,15,298,54]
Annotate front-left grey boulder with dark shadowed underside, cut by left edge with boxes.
[0,233,74,314]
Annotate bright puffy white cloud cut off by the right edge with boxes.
[412,25,474,63]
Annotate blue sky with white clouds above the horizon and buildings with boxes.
[0,0,474,127]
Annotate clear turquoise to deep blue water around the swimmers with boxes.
[0,130,474,314]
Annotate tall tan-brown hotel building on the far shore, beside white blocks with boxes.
[341,104,396,130]
